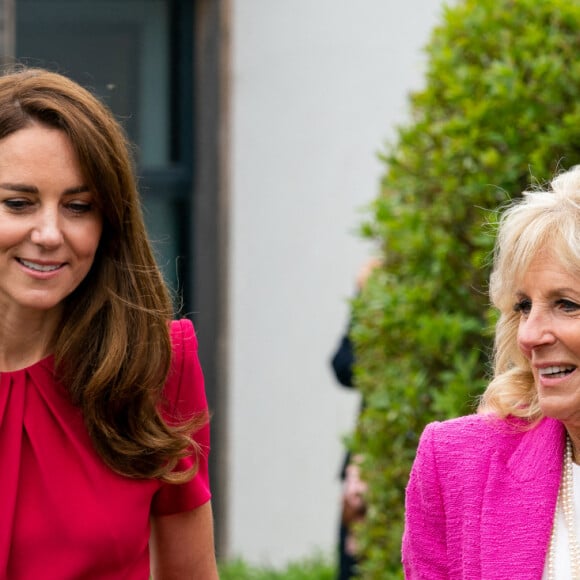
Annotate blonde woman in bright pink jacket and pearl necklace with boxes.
[403,168,580,580]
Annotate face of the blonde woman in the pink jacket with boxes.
[514,253,580,425]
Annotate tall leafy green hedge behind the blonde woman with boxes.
[352,0,580,580]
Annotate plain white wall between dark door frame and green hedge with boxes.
[228,0,441,566]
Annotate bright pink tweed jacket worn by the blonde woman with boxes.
[403,415,565,580]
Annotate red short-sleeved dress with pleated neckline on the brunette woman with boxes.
[0,320,210,580]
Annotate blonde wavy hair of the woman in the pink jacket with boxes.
[479,166,580,422]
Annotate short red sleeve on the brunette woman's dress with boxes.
[151,319,211,515]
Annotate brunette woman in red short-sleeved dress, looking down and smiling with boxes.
[0,68,217,580]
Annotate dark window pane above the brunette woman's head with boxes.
[16,0,171,168]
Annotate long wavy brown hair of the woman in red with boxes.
[0,67,207,483]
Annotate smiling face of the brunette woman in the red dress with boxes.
[0,124,103,314]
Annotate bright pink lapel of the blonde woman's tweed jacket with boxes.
[481,418,565,580]
